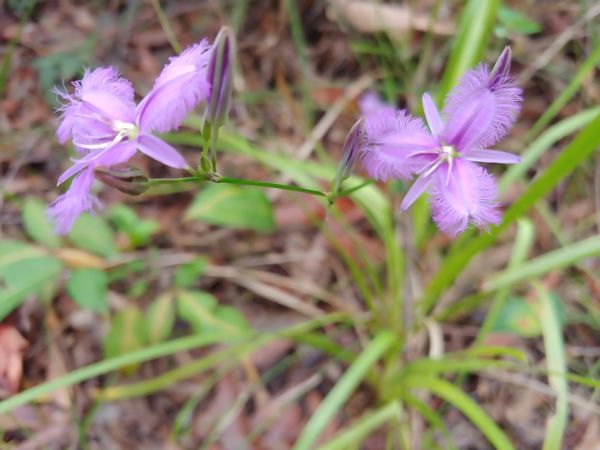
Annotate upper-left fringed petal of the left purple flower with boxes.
[55,67,135,143]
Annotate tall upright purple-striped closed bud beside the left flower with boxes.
[205,27,235,129]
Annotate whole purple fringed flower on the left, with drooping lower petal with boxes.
[48,41,210,234]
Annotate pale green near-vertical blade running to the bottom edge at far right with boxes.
[534,282,569,450]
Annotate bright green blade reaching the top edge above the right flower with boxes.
[437,0,500,102]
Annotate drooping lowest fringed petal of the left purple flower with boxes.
[47,167,99,234]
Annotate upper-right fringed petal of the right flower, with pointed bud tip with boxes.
[444,49,523,151]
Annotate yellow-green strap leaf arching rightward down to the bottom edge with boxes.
[406,375,514,450]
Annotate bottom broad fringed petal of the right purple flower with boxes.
[430,159,501,236]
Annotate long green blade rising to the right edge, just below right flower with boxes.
[421,115,600,313]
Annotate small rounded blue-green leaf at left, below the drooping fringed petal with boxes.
[67,268,108,314]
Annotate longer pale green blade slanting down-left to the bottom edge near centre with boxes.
[293,331,397,450]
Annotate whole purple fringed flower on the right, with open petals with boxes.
[362,47,522,236]
